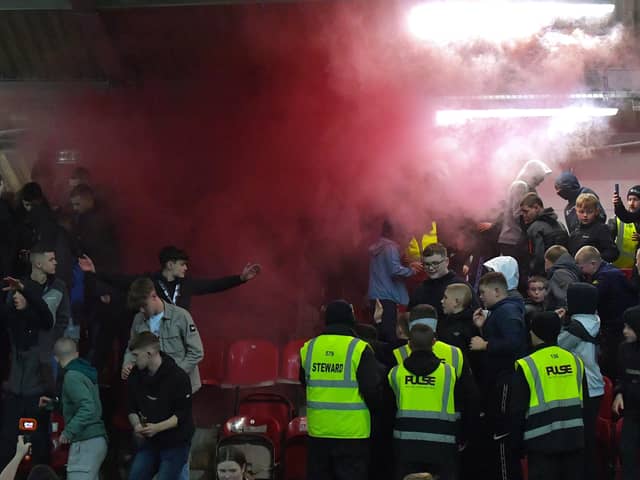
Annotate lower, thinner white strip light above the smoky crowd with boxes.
[436,107,618,127]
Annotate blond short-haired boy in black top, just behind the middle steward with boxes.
[438,283,478,352]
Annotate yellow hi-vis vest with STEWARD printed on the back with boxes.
[300,335,371,438]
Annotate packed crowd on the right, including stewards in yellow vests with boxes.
[300,165,640,480]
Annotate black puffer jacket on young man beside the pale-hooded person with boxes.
[527,207,569,275]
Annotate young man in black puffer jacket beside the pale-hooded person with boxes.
[520,193,569,275]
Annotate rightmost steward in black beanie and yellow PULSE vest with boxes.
[509,312,589,480]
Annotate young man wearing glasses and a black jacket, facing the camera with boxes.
[409,243,478,318]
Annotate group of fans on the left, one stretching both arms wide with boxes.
[0,168,261,480]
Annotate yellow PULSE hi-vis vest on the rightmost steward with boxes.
[516,346,584,445]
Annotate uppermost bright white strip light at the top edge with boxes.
[408,0,615,43]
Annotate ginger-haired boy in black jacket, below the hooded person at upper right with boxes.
[568,193,620,262]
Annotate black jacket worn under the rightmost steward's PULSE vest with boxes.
[509,343,589,455]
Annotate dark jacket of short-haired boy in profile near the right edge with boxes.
[591,262,638,334]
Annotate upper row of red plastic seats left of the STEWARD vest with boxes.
[199,339,306,388]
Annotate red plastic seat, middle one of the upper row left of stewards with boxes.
[221,340,278,388]
